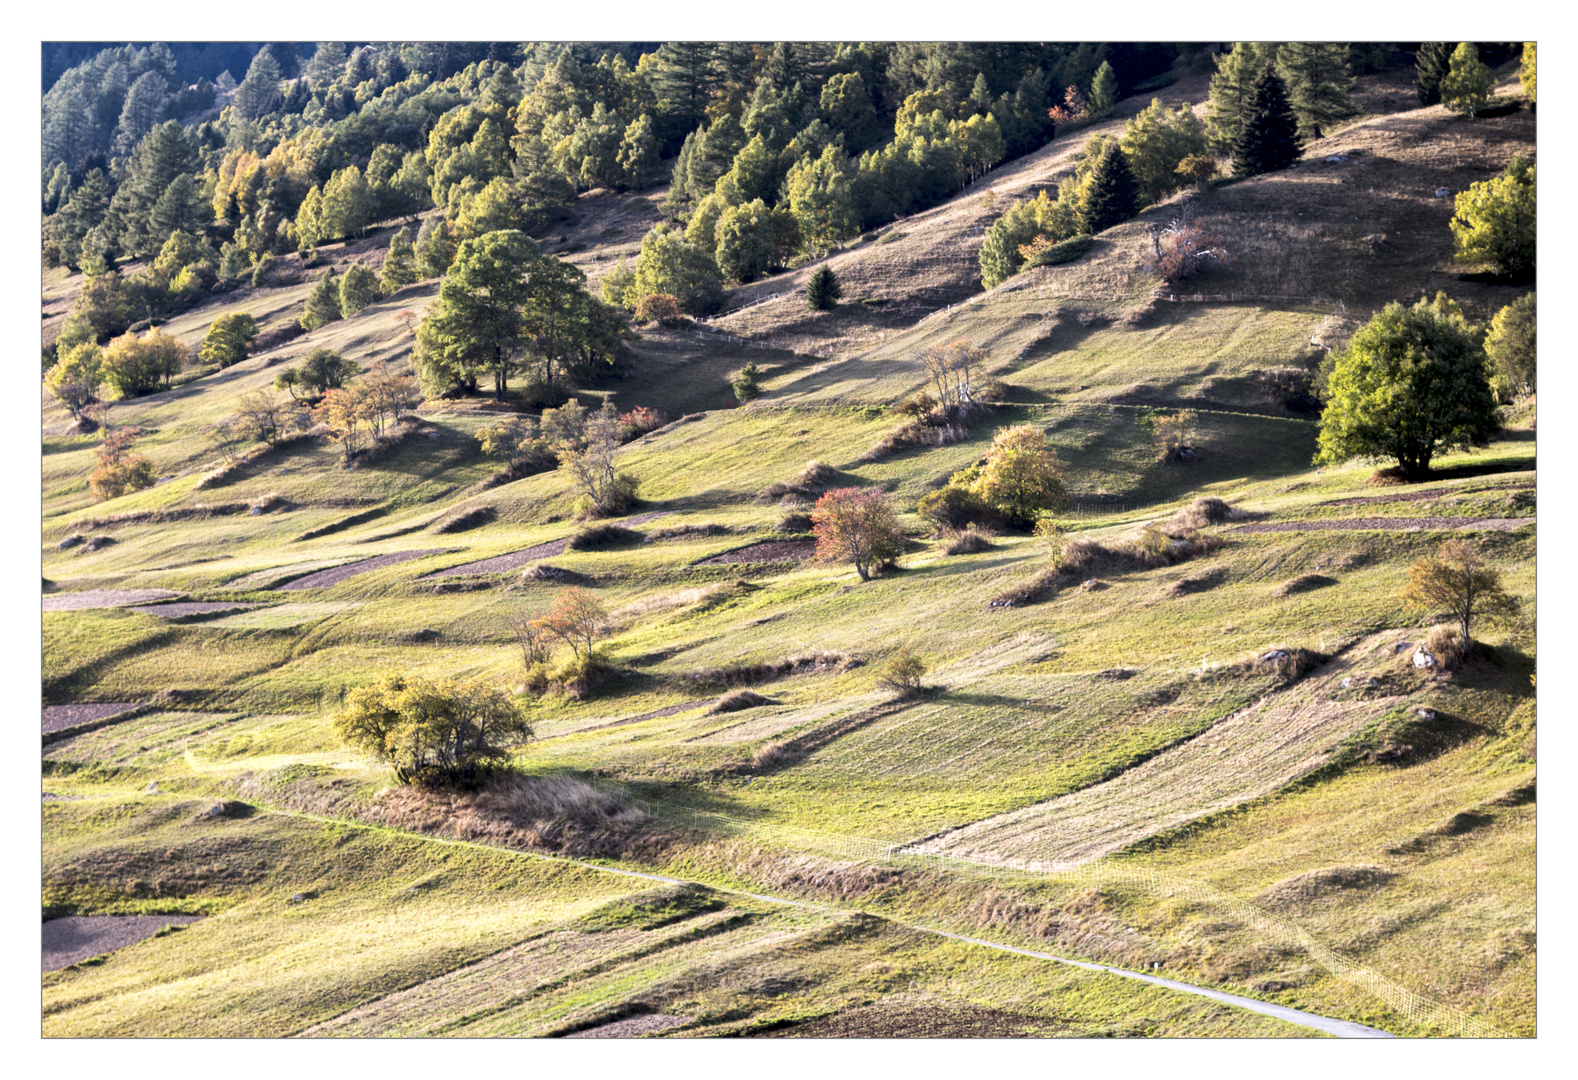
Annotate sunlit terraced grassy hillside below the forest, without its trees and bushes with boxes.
[41,56,1537,1036]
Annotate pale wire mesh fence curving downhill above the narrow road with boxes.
[595,782,1507,1039]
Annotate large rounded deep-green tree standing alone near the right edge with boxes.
[1316,294,1501,480]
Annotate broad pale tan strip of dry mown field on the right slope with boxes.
[912,630,1406,870]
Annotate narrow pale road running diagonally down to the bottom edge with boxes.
[262,807,1395,1039]
